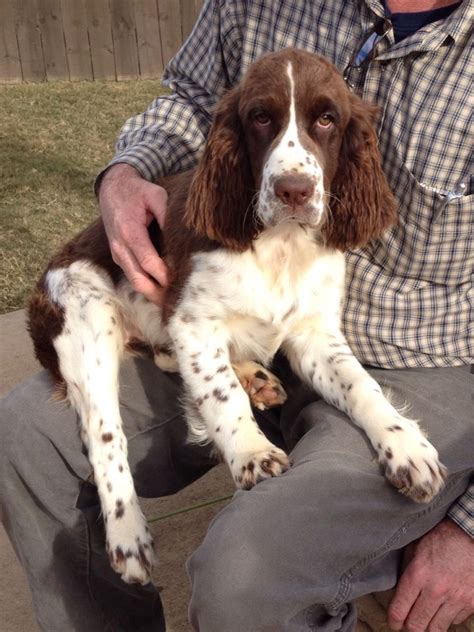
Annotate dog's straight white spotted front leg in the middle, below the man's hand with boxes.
[168,311,288,489]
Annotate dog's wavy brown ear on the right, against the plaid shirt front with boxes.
[323,94,397,250]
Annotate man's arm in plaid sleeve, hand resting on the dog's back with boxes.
[96,0,245,302]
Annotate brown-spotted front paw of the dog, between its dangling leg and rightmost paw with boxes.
[231,446,290,489]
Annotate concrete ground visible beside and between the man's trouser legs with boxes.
[0,311,474,632]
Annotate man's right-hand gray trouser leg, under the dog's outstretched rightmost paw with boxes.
[189,362,472,632]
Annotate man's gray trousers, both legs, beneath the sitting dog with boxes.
[0,360,474,632]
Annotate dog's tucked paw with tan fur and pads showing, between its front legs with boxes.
[232,361,287,410]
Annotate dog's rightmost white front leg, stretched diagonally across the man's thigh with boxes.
[285,327,446,502]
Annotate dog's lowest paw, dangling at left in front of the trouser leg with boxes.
[106,501,154,585]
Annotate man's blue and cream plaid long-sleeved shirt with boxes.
[104,0,474,528]
